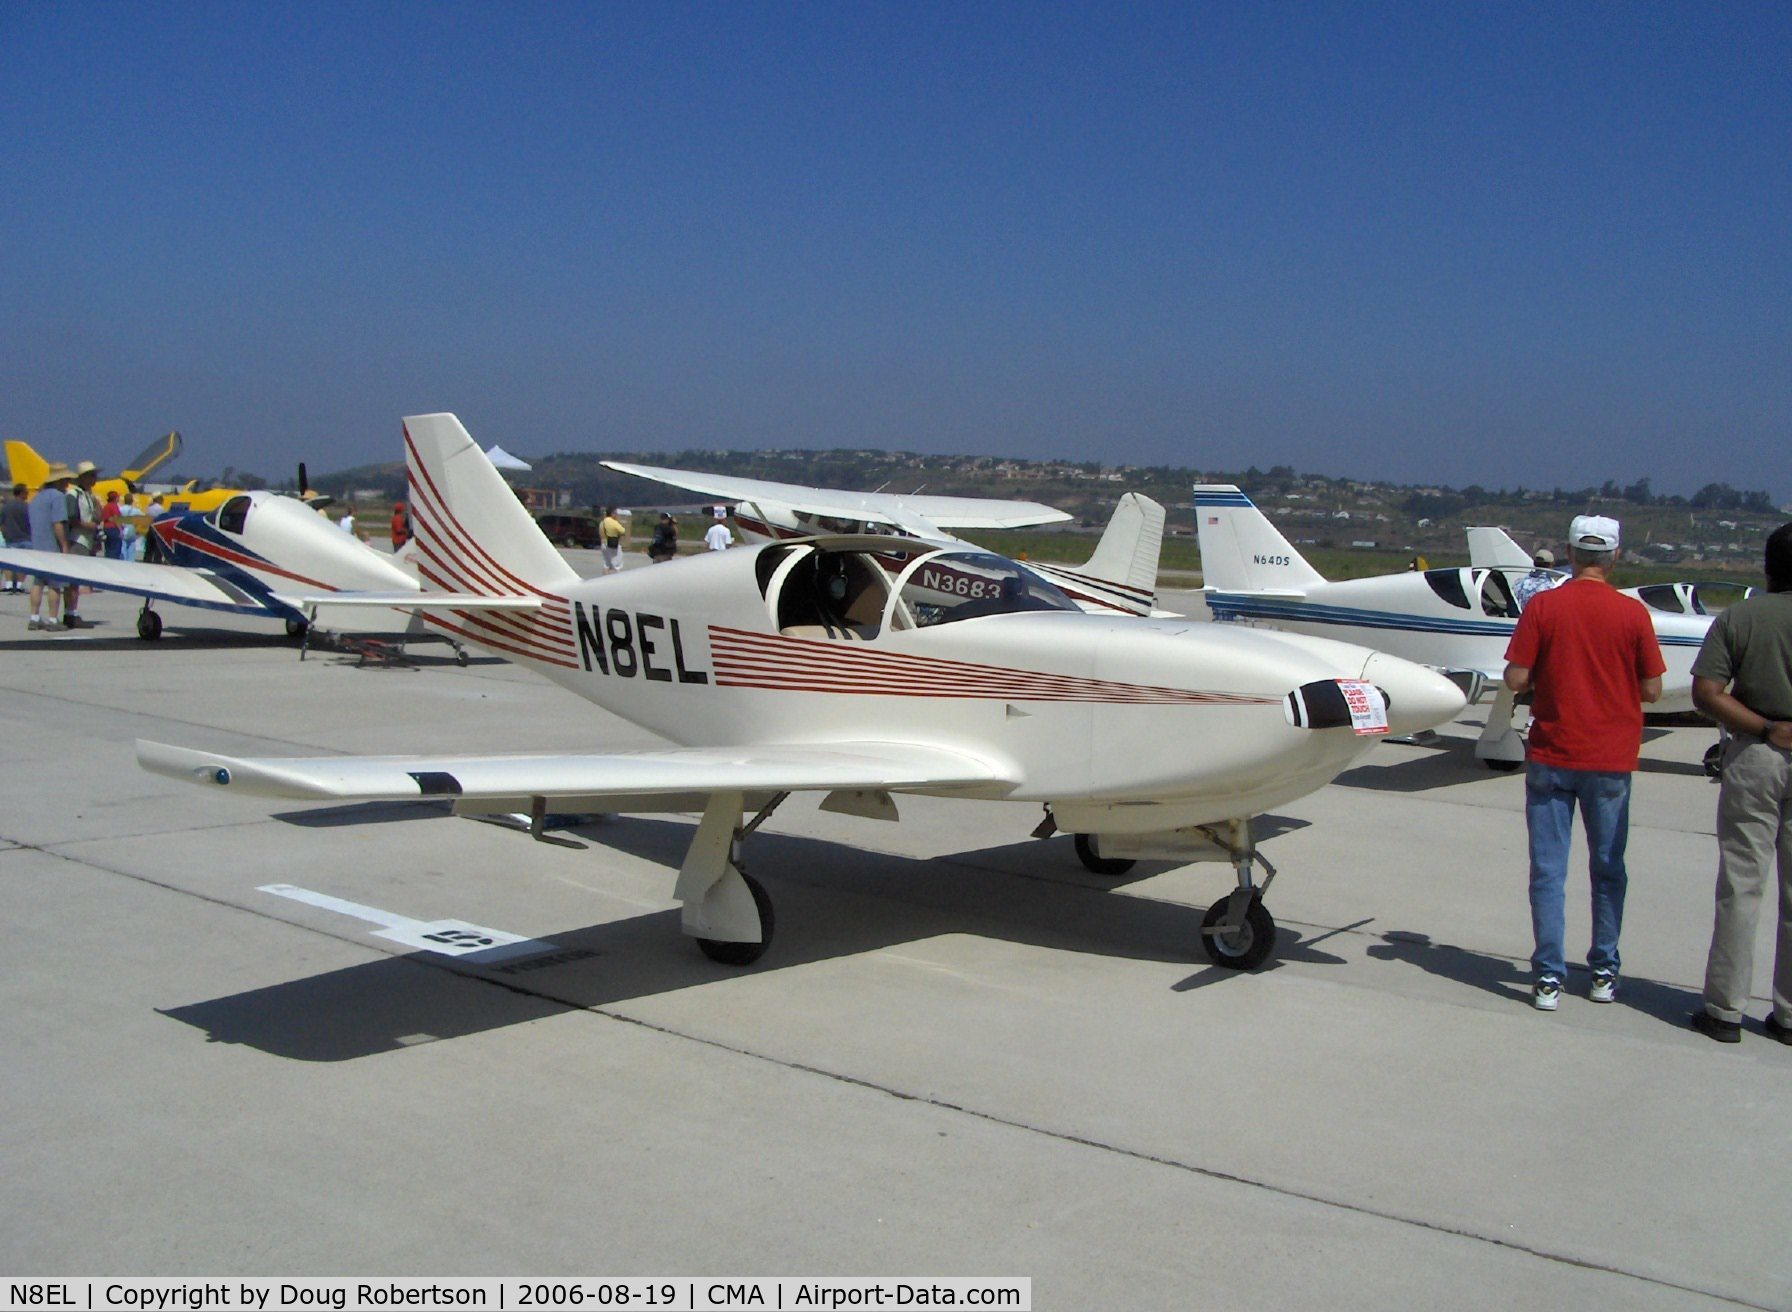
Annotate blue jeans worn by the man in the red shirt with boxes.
[1525,762,1631,984]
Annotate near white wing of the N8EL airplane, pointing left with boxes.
[136,738,1014,801]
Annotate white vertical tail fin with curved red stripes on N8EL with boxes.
[405,414,579,595]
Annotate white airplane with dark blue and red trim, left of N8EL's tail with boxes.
[0,491,514,642]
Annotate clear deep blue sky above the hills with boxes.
[0,0,1792,502]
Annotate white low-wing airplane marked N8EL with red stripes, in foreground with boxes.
[138,414,1464,968]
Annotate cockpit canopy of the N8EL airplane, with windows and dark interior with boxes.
[760,543,1081,642]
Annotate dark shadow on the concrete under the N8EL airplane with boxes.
[161,817,1342,1061]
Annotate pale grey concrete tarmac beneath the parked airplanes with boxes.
[0,580,1792,1308]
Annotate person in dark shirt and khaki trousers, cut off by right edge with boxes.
[1692,523,1792,1043]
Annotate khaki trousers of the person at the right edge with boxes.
[1704,738,1792,1025]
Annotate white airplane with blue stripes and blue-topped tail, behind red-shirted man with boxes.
[1195,484,1711,769]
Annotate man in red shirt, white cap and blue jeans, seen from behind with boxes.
[1505,514,1667,1011]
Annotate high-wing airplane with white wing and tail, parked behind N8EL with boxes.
[604,461,1163,615]
